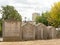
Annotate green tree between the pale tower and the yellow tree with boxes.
[35,11,49,25]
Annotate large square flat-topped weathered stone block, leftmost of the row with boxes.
[3,21,22,41]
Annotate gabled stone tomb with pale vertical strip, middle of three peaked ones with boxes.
[36,23,48,39]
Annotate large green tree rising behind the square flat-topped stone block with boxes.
[2,5,22,21]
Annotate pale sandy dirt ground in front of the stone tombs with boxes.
[0,39,60,45]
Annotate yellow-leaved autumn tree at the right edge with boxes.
[48,2,60,27]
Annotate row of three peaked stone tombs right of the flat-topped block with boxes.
[22,23,56,39]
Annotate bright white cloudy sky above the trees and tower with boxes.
[0,0,60,21]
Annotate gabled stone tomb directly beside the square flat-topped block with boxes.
[22,22,35,40]
